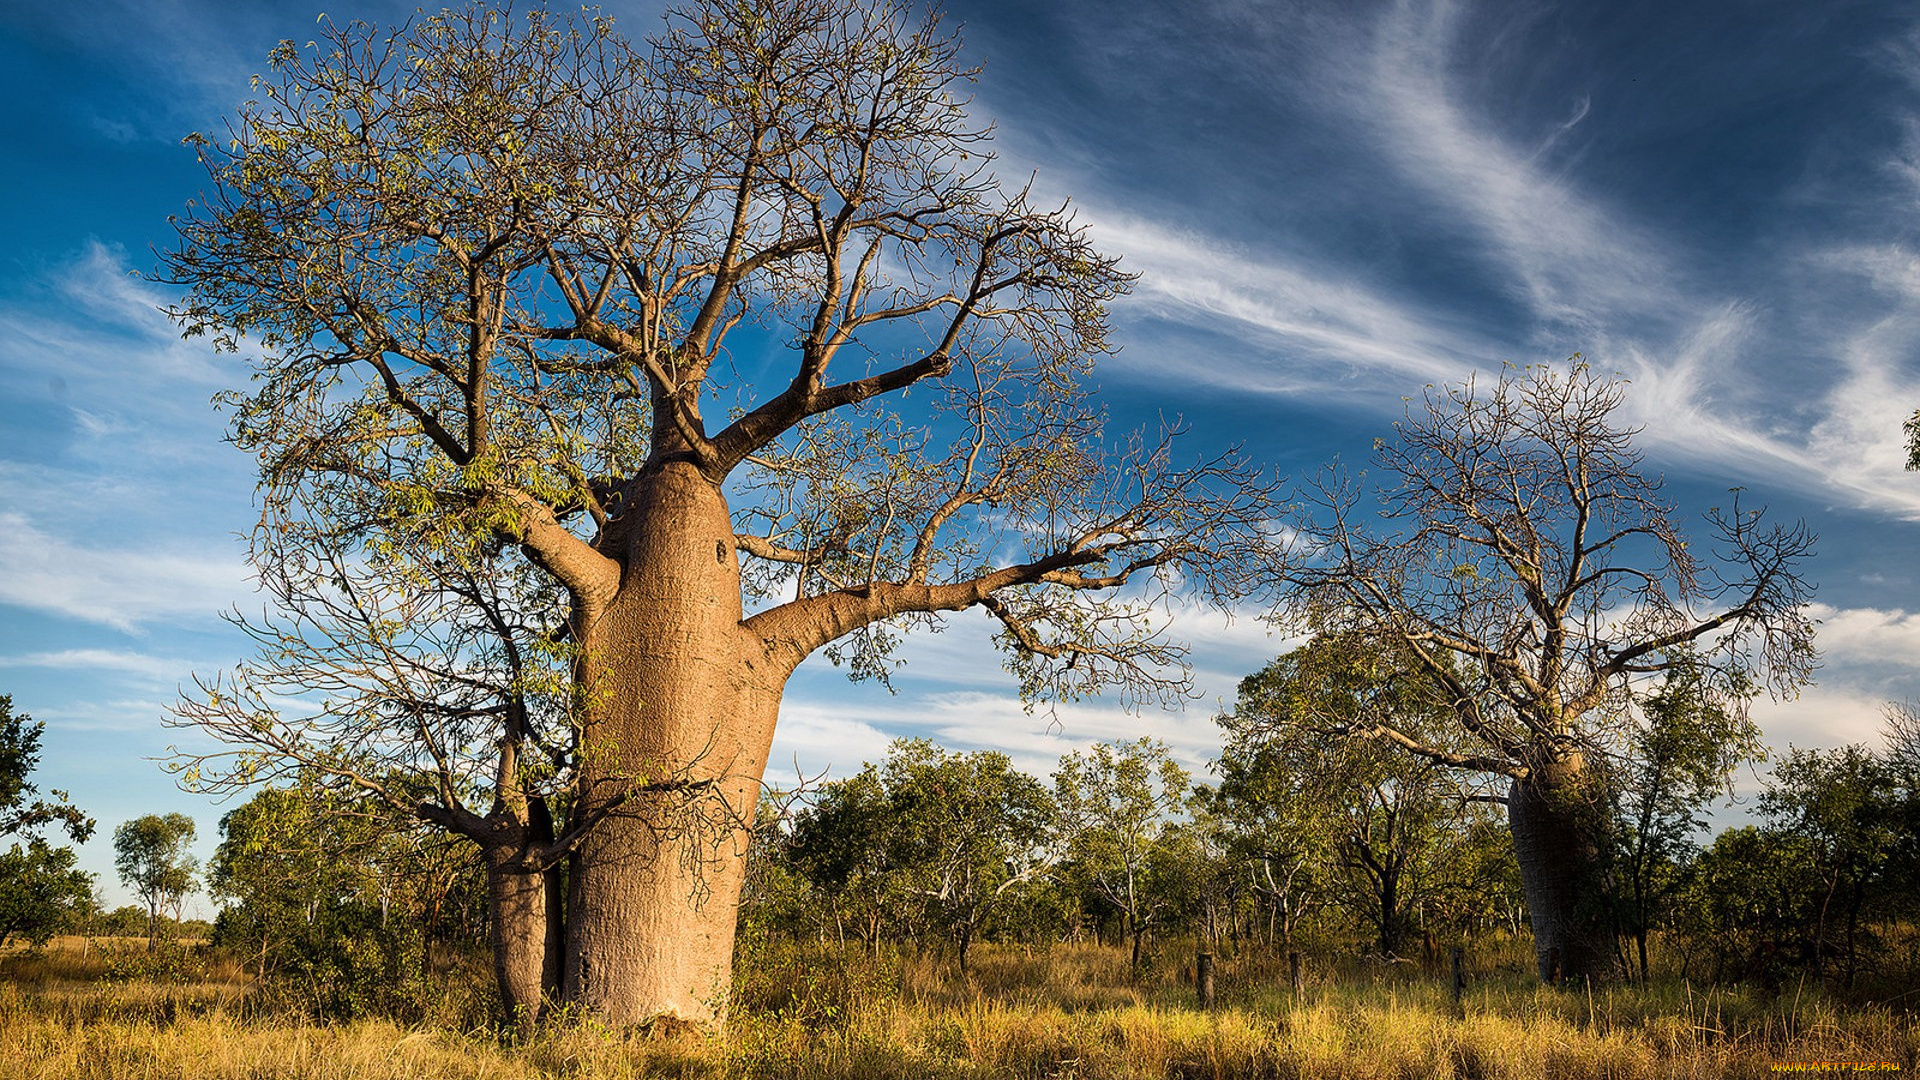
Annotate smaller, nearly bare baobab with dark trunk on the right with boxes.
[1279,357,1814,976]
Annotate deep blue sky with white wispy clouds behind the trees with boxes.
[0,0,1920,901]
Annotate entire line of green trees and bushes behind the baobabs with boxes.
[0,668,1920,1017]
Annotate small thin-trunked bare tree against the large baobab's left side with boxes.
[169,494,597,1022]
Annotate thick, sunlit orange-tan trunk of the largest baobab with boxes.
[563,461,787,1026]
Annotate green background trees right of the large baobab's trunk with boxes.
[721,676,1920,988]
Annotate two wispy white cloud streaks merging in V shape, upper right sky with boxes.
[1052,0,1920,519]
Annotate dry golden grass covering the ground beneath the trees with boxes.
[0,930,1920,1080]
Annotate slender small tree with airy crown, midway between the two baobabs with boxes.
[1054,738,1188,972]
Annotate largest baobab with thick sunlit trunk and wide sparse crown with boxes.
[165,0,1271,1024]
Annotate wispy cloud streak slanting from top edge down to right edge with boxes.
[1346,0,1920,517]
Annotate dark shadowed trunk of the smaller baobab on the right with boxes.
[1507,757,1615,980]
